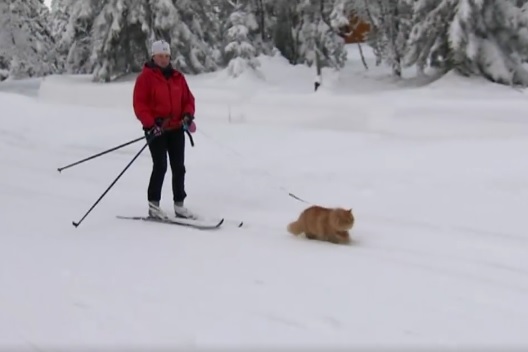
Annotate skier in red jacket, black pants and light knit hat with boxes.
[133,40,197,219]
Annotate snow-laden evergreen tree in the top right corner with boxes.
[449,0,528,86]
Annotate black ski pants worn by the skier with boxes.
[144,128,187,202]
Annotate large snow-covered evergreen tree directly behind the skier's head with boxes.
[92,0,221,81]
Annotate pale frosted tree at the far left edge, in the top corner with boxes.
[0,0,58,80]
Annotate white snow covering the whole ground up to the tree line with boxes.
[0,47,528,351]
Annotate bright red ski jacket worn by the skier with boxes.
[133,62,194,129]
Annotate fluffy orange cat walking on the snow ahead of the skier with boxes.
[288,205,355,244]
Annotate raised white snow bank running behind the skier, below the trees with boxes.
[33,49,528,139]
